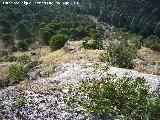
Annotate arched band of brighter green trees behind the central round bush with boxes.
[40,16,104,45]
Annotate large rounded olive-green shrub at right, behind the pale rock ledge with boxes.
[106,42,137,68]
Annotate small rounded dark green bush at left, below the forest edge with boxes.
[17,40,29,51]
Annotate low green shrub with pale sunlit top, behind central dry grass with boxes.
[82,37,103,50]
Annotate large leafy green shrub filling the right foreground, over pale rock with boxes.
[64,74,160,120]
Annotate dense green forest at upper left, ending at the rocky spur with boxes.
[0,3,104,51]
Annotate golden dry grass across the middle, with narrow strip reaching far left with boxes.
[13,41,103,64]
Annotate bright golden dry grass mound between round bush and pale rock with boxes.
[40,41,103,64]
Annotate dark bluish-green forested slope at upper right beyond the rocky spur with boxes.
[78,0,160,50]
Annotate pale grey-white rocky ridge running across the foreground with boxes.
[0,58,160,120]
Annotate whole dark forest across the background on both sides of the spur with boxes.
[0,0,160,50]
